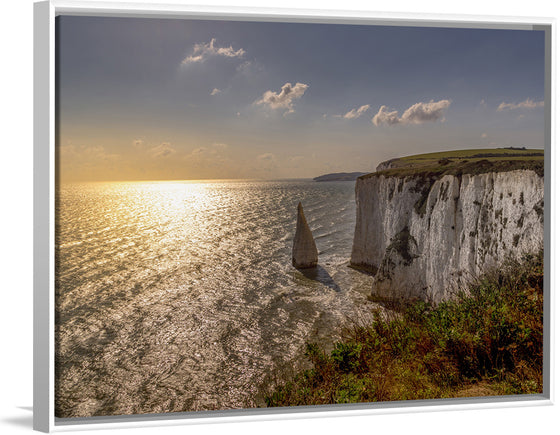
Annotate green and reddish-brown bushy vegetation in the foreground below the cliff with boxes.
[265,253,543,406]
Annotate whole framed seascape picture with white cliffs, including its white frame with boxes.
[33,1,553,432]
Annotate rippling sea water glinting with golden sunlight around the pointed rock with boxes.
[55,180,372,417]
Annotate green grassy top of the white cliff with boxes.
[366,148,544,179]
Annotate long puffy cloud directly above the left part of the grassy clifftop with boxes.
[371,100,451,125]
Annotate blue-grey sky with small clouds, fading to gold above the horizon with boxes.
[56,16,545,182]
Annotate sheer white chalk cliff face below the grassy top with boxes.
[351,170,544,303]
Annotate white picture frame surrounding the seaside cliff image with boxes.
[33,0,555,432]
